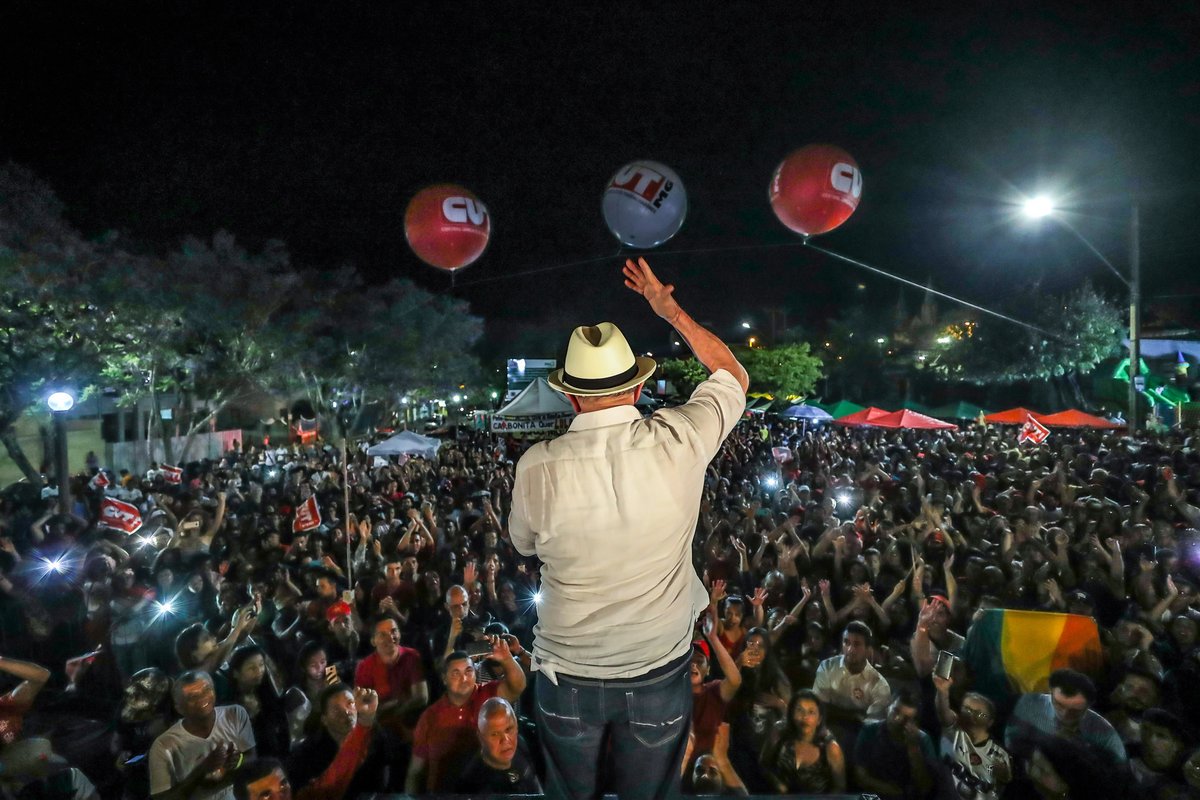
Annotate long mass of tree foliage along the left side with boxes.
[0,159,484,482]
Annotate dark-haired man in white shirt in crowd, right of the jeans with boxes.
[812,620,892,723]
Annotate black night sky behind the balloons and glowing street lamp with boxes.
[0,0,1200,355]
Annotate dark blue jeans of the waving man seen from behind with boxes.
[536,657,691,800]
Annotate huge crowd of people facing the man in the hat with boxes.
[0,419,1200,800]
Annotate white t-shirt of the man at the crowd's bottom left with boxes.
[149,705,254,800]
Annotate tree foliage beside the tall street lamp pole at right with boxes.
[930,283,1123,384]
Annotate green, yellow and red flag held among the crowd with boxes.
[962,608,1104,704]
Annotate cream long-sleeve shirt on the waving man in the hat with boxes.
[509,369,745,682]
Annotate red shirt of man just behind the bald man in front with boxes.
[413,680,500,792]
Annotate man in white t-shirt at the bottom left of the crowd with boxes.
[149,669,254,800]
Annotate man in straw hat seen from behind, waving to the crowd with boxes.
[509,259,749,800]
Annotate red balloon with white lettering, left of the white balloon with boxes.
[404,184,492,272]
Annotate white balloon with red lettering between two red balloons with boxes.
[601,161,688,248]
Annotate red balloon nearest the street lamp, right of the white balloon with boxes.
[768,144,863,236]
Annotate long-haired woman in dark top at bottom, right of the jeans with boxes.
[762,688,846,794]
